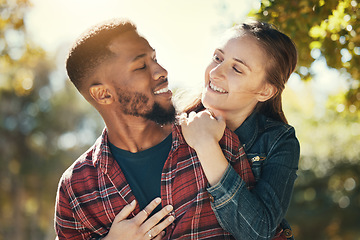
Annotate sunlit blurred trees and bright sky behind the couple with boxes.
[0,0,360,240]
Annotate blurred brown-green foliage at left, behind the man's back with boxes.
[0,0,100,240]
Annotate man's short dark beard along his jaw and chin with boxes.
[117,89,176,125]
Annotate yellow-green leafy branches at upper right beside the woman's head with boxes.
[250,0,360,110]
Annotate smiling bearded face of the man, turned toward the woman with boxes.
[98,31,175,124]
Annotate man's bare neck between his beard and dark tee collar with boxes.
[106,119,172,153]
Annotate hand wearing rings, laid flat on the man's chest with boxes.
[103,198,174,240]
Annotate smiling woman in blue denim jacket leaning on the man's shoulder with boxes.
[180,21,300,239]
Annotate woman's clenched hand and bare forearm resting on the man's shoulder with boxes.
[180,110,228,186]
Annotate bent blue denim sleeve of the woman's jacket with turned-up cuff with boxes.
[207,128,300,239]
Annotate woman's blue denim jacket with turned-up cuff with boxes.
[207,113,300,240]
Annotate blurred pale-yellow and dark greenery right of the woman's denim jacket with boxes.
[283,85,360,240]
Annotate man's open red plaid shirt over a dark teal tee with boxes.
[55,126,255,239]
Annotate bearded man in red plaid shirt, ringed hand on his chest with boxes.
[55,17,255,240]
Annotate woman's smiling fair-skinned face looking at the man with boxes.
[202,34,272,118]
